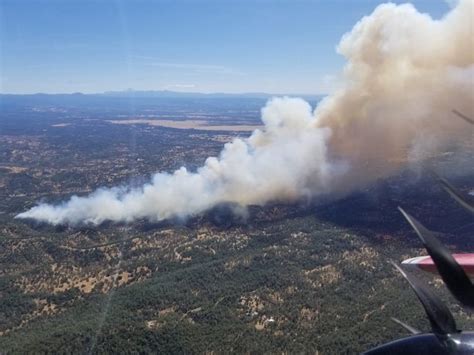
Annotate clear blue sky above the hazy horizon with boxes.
[0,0,449,94]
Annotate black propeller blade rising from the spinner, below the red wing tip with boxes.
[392,261,458,335]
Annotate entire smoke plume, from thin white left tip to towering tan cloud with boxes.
[17,0,474,224]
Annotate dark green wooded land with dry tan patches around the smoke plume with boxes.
[0,101,474,354]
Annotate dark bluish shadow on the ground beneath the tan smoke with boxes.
[313,171,474,250]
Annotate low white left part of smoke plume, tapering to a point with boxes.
[19,98,332,224]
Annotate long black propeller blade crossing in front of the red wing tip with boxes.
[398,207,474,309]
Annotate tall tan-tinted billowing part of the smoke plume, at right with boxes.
[315,0,474,190]
